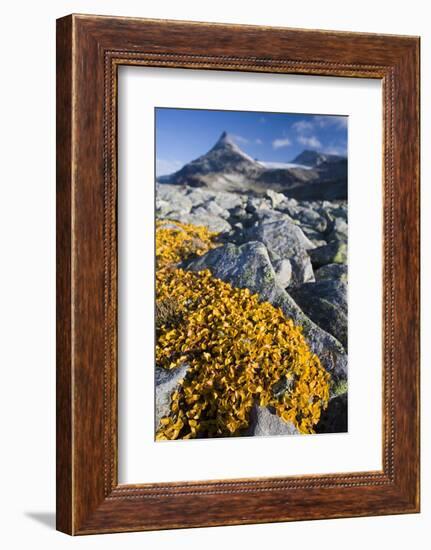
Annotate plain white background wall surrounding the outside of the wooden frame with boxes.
[0,0,431,550]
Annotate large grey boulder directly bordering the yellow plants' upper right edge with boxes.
[184,242,347,380]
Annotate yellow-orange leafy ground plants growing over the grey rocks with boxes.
[156,222,330,439]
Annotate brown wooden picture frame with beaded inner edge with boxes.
[57,15,419,535]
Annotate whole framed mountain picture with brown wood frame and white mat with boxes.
[57,15,419,535]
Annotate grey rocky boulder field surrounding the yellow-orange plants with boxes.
[156,183,348,435]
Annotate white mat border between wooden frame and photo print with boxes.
[118,67,383,483]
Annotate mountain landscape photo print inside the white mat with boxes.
[154,108,348,441]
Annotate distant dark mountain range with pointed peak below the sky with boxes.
[158,132,347,199]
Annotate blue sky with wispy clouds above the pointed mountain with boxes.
[156,108,347,176]
